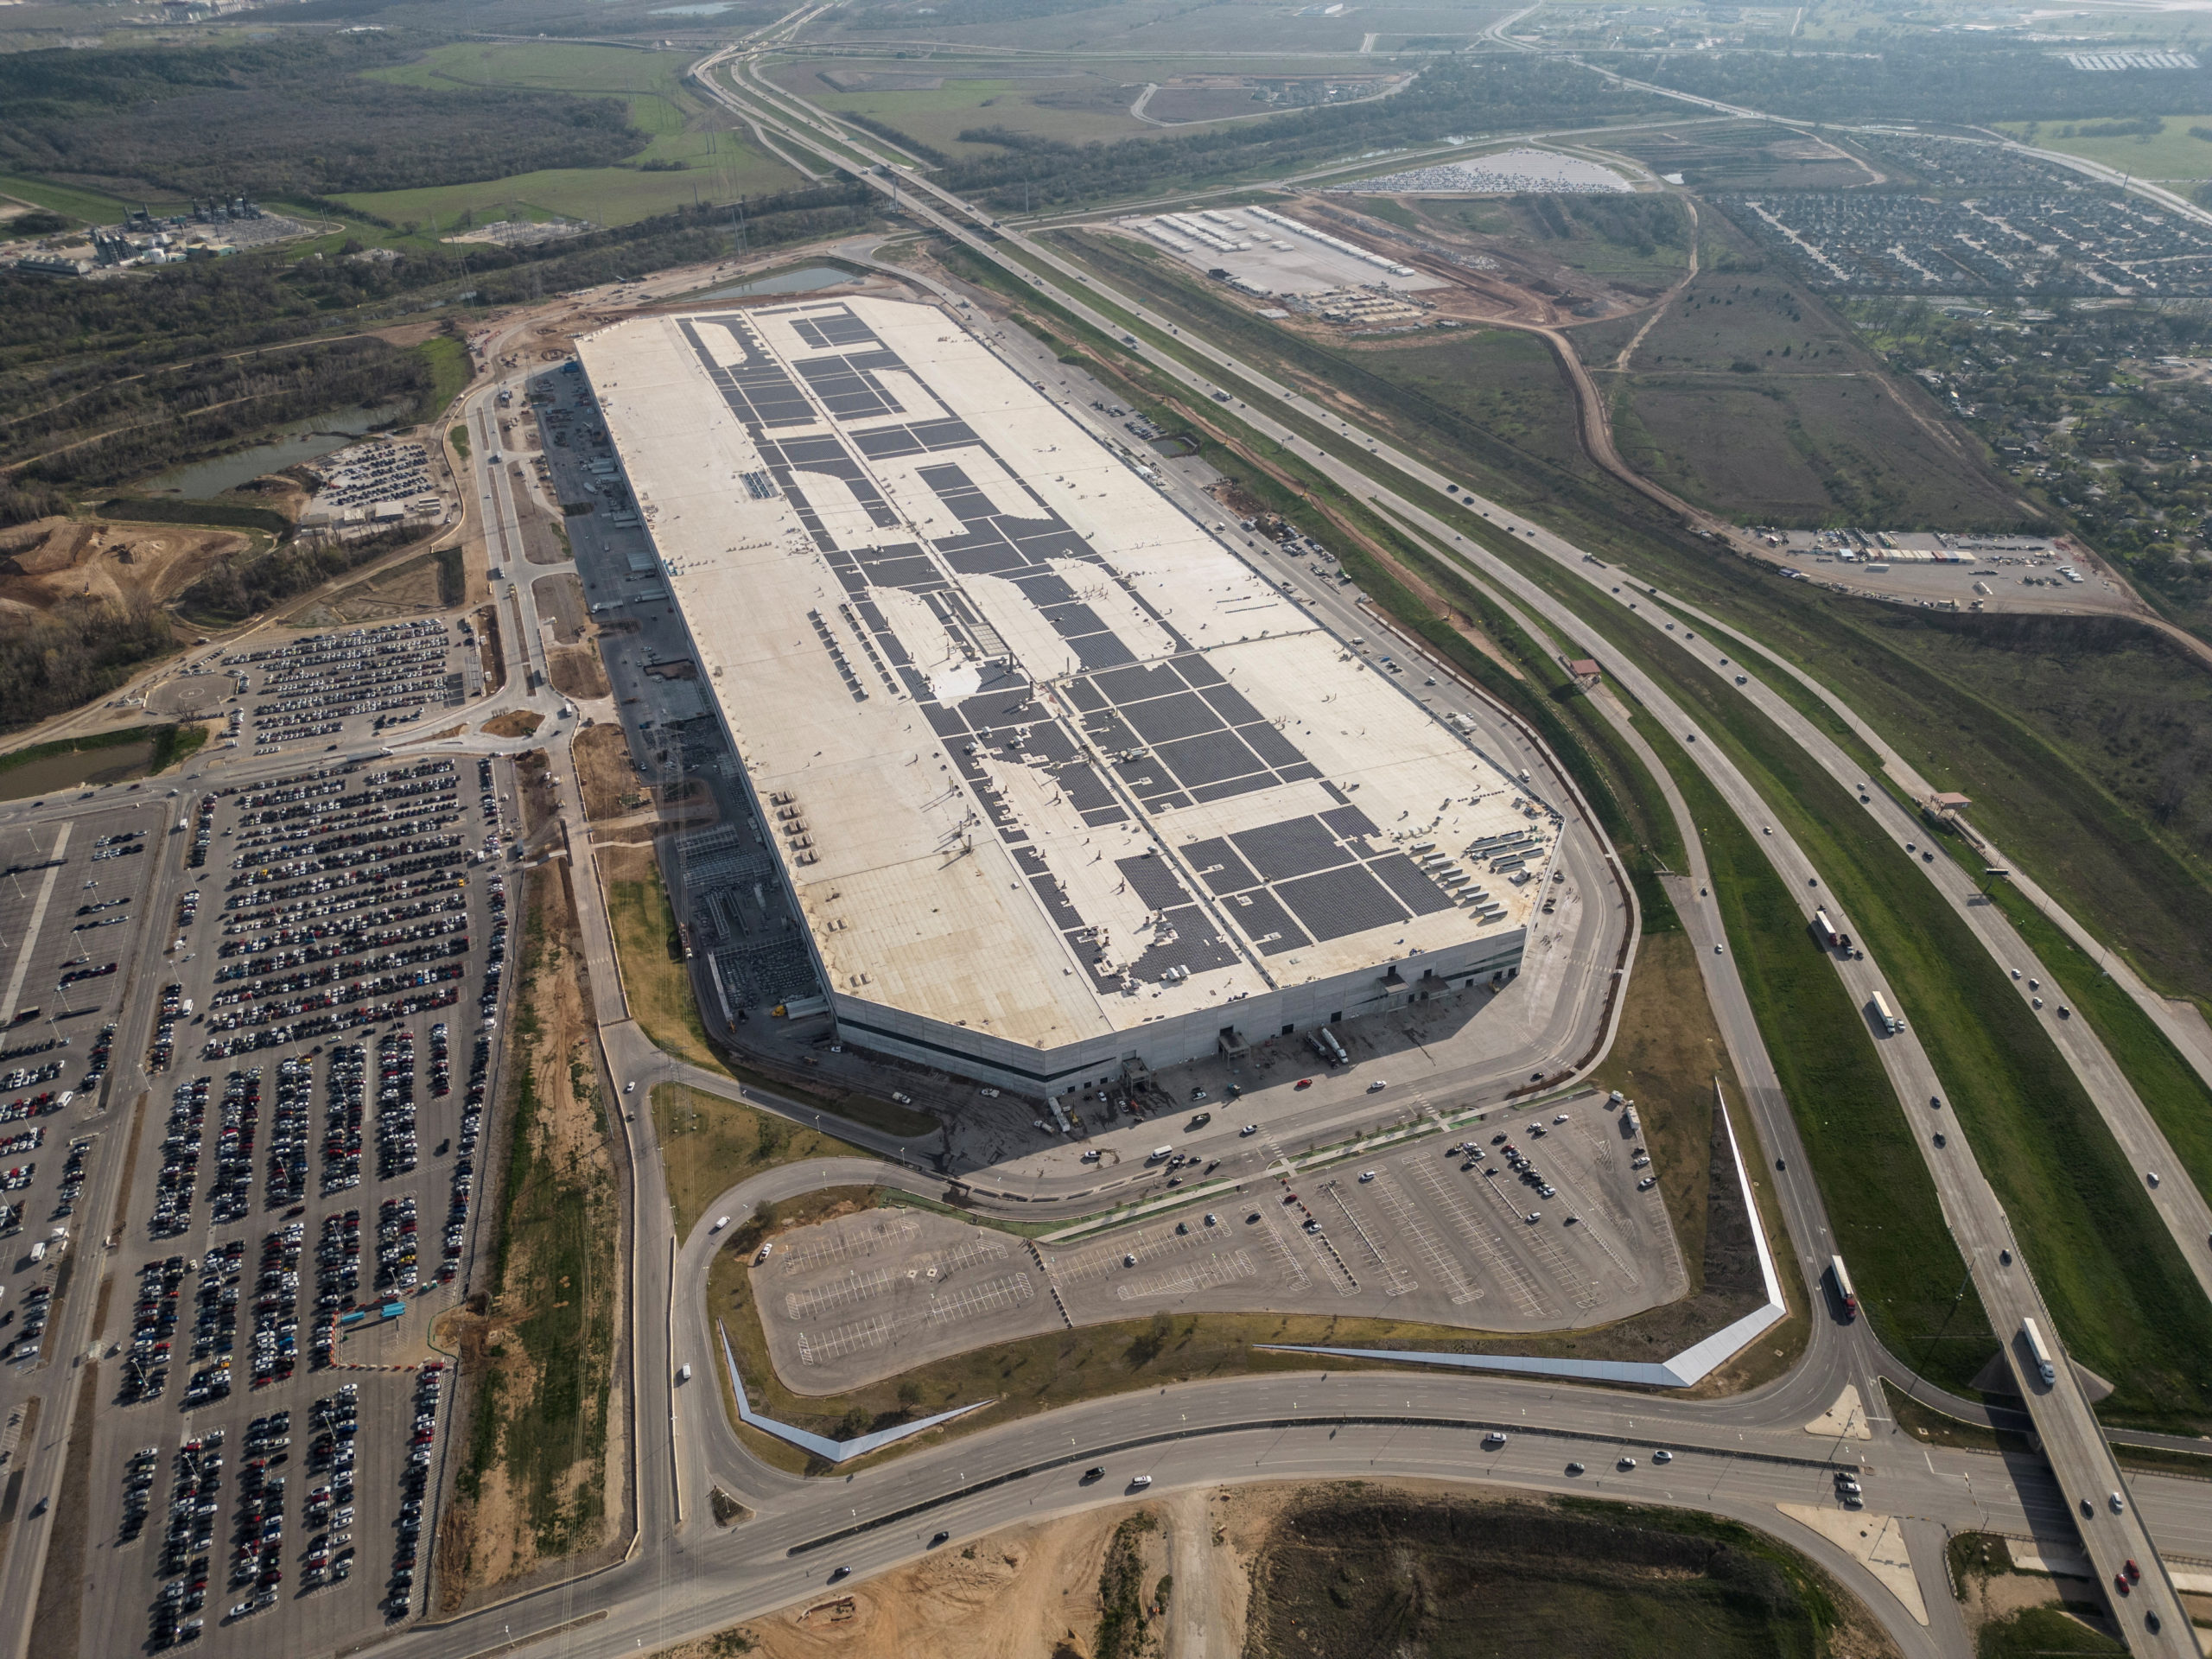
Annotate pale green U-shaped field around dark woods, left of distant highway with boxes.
[343,42,801,234]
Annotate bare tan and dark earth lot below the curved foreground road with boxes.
[657,1482,1896,1659]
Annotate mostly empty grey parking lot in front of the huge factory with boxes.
[752,1099,1688,1394]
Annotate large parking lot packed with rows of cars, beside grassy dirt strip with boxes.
[59,752,515,1652]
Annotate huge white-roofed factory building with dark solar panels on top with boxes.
[577,299,1560,1095]
